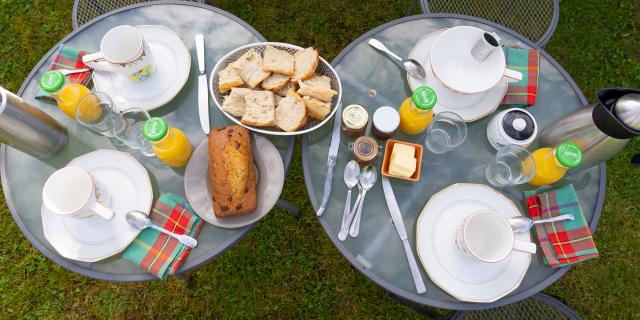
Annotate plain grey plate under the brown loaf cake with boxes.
[184,135,284,228]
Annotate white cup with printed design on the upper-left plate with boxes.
[82,25,156,82]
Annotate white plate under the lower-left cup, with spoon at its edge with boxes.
[41,149,153,262]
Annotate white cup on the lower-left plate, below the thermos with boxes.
[42,167,114,220]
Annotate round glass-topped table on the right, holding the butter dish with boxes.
[302,14,605,310]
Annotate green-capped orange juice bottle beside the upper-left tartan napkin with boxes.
[40,70,93,120]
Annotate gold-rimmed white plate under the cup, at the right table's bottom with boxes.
[416,183,531,303]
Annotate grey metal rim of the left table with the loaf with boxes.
[0,0,276,282]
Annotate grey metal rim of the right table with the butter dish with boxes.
[302,13,606,310]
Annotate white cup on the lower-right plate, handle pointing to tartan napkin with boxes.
[456,211,536,263]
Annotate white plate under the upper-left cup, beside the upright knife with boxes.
[93,25,191,111]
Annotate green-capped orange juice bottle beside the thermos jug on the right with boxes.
[529,142,582,187]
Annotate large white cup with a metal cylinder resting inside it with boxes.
[429,26,522,94]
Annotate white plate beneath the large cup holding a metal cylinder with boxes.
[407,29,508,122]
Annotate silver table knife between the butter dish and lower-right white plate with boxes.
[382,176,427,293]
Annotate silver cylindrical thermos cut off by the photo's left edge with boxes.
[0,87,68,159]
